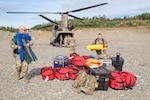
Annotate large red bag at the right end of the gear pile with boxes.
[109,71,137,90]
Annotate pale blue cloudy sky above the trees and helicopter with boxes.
[0,0,150,28]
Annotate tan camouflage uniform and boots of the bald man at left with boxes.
[10,35,33,83]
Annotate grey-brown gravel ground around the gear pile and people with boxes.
[0,28,150,100]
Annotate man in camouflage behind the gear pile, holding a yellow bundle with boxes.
[93,33,108,59]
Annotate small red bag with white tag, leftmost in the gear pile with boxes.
[41,66,55,81]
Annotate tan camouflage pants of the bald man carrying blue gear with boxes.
[14,54,28,75]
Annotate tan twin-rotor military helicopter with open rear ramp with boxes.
[7,3,108,46]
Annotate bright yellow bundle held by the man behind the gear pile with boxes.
[86,44,106,50]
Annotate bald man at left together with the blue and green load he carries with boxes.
[10,25,37,83]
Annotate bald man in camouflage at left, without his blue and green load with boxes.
[10,26,36,83]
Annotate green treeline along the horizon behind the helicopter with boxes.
[0,13,150,32]
